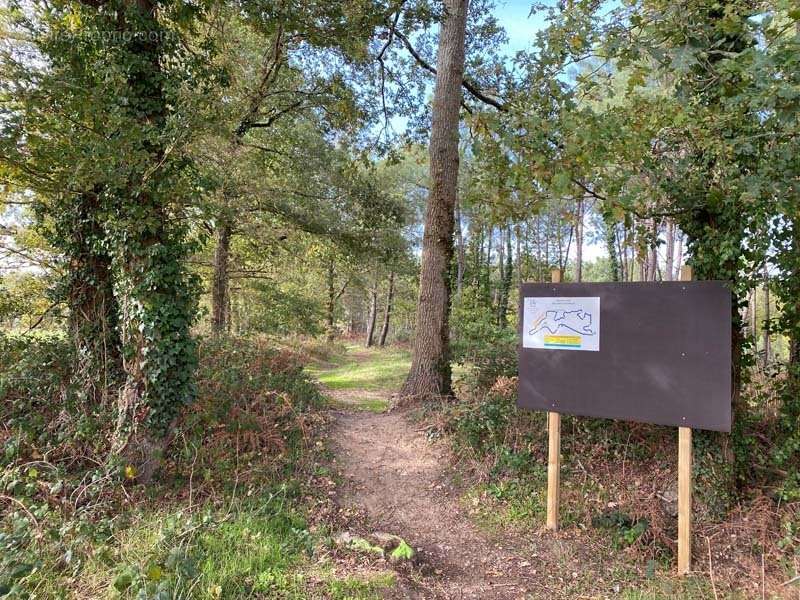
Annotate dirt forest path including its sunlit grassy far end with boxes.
[312,348,535,599]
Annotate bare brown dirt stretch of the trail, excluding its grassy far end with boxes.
[333,411,536,600]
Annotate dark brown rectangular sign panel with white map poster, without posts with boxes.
[518,281,731,431]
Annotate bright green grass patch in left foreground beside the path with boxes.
[31,488,395,600]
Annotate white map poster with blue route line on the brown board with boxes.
[522,296,600,352]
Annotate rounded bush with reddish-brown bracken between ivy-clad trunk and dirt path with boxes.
[173,337,324,485]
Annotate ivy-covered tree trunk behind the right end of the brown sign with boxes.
[671,3,760,497]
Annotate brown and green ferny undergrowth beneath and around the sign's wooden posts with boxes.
[425,370,800,598]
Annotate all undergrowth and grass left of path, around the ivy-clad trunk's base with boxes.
[0,336,360,600]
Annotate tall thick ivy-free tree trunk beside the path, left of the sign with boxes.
[401,0,469,398]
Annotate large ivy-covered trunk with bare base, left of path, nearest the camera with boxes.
[113,0,196,483]
